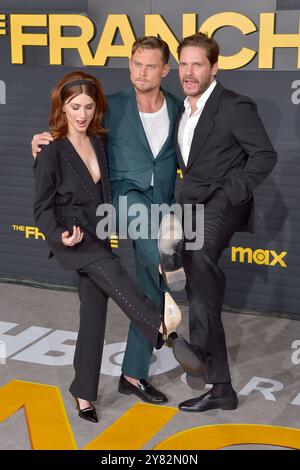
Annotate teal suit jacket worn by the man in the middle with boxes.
[105,87,181,204]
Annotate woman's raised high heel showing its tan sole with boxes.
[156,292,182,349]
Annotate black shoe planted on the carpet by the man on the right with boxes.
[178,390,238,413]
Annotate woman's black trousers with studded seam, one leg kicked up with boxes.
[70,252,162,401]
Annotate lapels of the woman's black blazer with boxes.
[61,137,105,200]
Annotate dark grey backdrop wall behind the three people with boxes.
[0,0,300,315]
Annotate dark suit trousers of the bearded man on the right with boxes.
[183,188,251,384]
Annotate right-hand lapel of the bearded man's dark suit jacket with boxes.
[187,83,223,170]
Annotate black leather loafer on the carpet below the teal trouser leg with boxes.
[118,374,168,405]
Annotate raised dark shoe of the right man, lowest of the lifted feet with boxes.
[173,337,207,385]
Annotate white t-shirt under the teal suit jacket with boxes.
[139,99,170,186]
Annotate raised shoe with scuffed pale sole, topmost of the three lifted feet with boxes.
[157,214,186,291]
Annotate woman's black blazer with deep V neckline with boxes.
[33,136,111,270]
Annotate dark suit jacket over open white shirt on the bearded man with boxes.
[175,83,277,231]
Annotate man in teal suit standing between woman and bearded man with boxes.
[105,36,181,403]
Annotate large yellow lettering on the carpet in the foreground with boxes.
[0,380,300,450]
